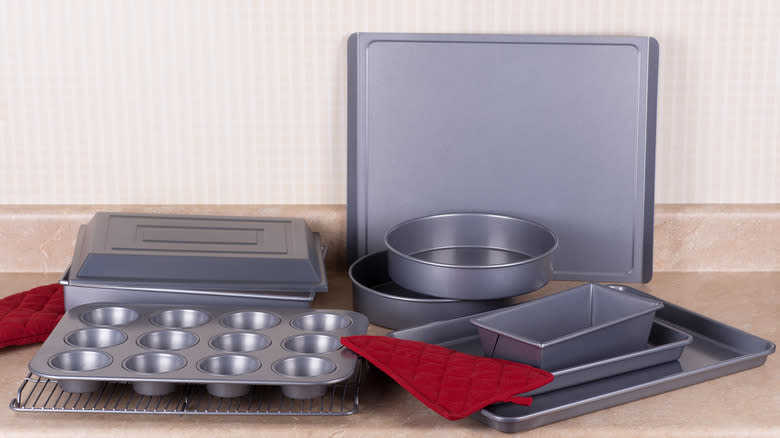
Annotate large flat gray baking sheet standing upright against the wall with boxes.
[347,33,658,282]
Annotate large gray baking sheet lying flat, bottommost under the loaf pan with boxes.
[390,286,775,433]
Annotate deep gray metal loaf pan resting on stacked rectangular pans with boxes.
[471,283,663,370]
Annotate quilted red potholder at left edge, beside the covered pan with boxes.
[0,284,65,348]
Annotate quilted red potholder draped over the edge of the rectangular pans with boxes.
[341,336,553,420]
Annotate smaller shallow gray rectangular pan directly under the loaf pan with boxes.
[388,316,692,397]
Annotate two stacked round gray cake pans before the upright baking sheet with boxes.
[349,213,558,329]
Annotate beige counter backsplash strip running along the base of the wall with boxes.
[0,204,780,273]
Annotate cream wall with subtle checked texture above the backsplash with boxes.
[0,0,780,204]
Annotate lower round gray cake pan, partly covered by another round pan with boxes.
[349,251,512,330]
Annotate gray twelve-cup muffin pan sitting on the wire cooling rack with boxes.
[29,303,368,399]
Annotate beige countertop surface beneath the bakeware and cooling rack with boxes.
[0,272,780,438]
